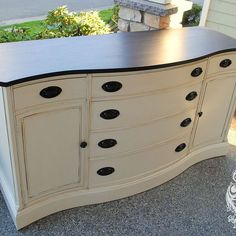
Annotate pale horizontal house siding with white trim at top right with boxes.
[201,0,236,38]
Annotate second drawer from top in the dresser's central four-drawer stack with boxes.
[91,84,201,130]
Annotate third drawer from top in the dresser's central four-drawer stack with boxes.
[89,110,195,158]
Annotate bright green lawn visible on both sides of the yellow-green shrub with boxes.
[0,9,113,35]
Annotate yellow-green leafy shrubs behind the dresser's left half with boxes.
[0,6,111,43]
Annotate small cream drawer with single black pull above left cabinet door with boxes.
[13,78,86,110]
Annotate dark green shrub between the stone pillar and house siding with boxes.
[182,4,202,27]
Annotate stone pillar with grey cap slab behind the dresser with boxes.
[114,0,193,32]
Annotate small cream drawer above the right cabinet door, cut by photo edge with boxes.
[207,52,236,74]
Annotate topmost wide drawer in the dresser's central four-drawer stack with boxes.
[92,60,207,98]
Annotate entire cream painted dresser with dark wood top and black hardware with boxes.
[0,28,236,229]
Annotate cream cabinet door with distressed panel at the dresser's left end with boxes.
[17,106,83,197]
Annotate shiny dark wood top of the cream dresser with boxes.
[0,27,236,87]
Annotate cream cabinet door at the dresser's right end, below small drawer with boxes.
[194,77,236,146]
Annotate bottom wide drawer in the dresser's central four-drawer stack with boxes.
[89,133,189,187]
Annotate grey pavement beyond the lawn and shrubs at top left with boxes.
[0,0,113,23]
